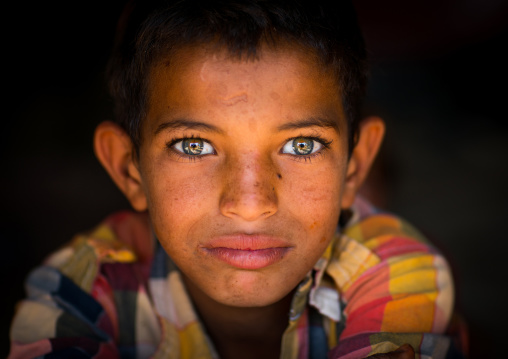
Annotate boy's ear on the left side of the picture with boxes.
[94,121,147,211]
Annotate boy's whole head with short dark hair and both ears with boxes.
[95,1,384,307]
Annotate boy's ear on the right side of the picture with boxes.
[341,116,385,209]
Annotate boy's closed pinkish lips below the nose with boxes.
[201,234,292,270]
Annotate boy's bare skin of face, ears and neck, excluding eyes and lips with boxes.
[95,48,384,358]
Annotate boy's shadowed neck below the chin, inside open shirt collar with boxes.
[184,277,293,359]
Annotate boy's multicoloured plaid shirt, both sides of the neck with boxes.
[9,200,460,359]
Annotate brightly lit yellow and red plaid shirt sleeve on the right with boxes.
[329,215,460,359]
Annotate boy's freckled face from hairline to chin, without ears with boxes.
[137,49,354,307]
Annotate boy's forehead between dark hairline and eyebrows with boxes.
[147,47,345,134]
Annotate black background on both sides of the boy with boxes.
[0,0,508,358]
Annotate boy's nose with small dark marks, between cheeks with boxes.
[219,154,277,221]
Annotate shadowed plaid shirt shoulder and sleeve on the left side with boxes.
[11,212,153,357]
